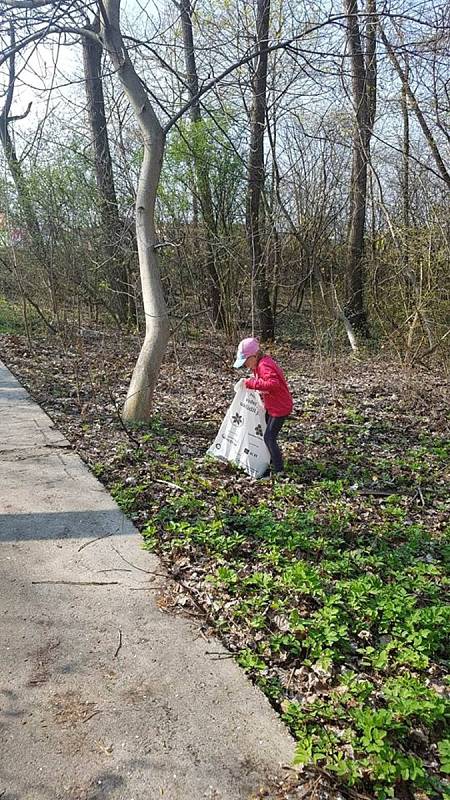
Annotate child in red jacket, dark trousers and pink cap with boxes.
[234,338,293,473]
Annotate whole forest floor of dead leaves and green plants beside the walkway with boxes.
[0,334,450,800]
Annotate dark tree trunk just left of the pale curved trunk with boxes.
[82,17,130,322]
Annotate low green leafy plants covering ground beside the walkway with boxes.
[139,467,450,800]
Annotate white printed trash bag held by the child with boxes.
[207,379,270,478]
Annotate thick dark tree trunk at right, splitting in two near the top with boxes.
[344,0,376,335]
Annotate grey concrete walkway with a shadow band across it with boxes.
[0,362,293,800]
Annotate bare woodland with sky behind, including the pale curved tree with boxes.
[0,0,450,420]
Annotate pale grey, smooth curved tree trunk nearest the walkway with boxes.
[102,0,169,421]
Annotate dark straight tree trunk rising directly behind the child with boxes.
[246,0,275,340]
